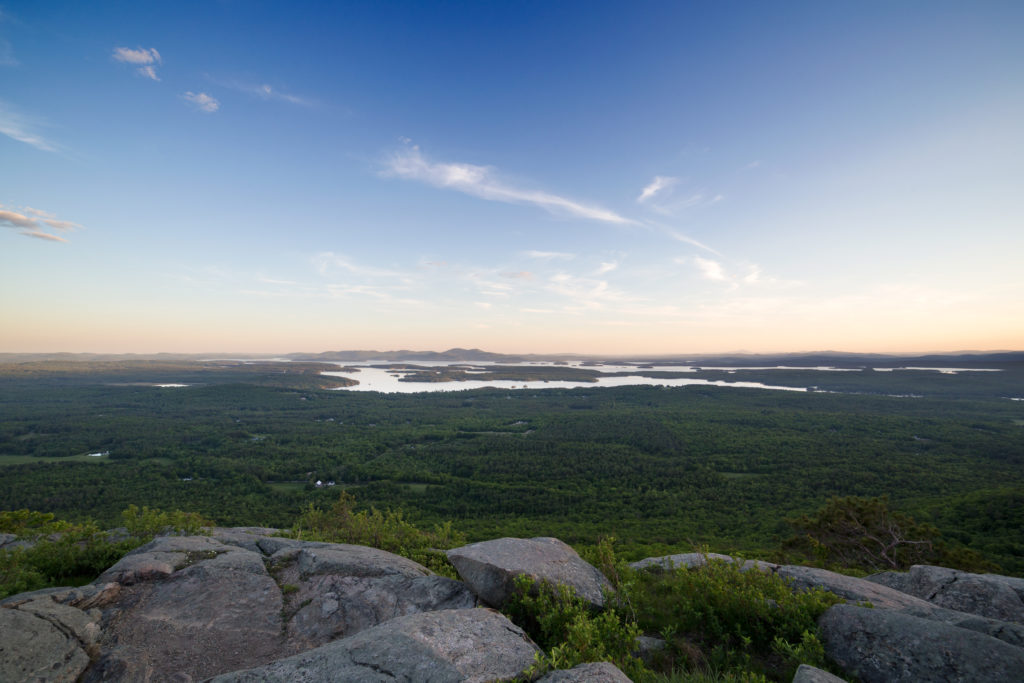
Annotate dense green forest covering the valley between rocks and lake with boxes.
[0,360,1024,573]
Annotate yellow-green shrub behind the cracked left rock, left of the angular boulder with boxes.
[280,490,466,579]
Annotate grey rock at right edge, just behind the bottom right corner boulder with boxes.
[867,564,1024,625]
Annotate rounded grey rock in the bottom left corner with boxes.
[0,608,89,683]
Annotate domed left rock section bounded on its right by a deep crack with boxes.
[85,537,291,681]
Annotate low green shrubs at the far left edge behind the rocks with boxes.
[0,505,212,598]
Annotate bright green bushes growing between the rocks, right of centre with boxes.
[505,541,842,681]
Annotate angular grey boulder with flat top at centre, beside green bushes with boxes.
[447,538,612,607]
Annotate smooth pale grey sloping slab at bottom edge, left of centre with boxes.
[211,609,540,683]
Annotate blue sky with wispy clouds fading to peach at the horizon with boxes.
[0,0,1024,354]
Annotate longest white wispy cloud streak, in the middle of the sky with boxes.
[384,146,637,225]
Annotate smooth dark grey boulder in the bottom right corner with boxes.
[818,604,1024,683]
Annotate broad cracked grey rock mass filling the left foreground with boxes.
[0,528,476,682]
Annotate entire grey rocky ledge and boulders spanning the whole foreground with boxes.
[6,527,1024,683]
